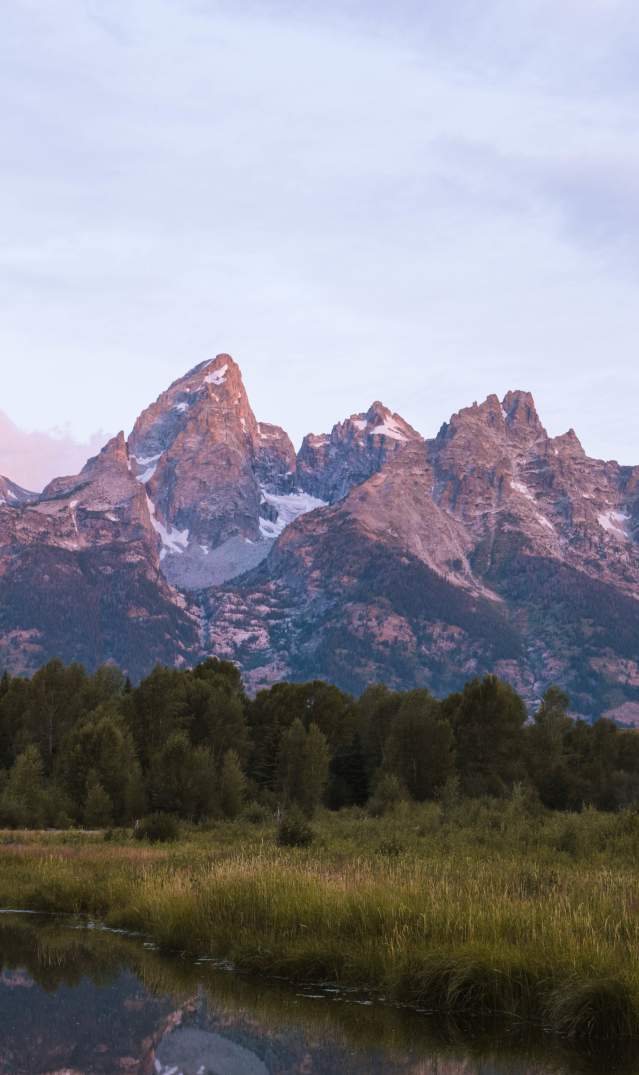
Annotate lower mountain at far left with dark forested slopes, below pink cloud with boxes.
[0,434,199,677]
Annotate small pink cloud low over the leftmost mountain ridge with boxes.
[0,411,107,491]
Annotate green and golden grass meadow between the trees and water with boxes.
[0,798,639,1040]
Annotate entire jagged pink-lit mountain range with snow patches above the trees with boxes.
[0,355,639,723]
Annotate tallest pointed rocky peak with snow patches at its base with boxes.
[129,355,322,589]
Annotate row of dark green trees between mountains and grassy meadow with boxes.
[0,658,639,828]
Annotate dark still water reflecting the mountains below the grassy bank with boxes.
[0,914,628,1075]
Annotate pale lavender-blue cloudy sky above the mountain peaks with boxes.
[0,0,639,488]
